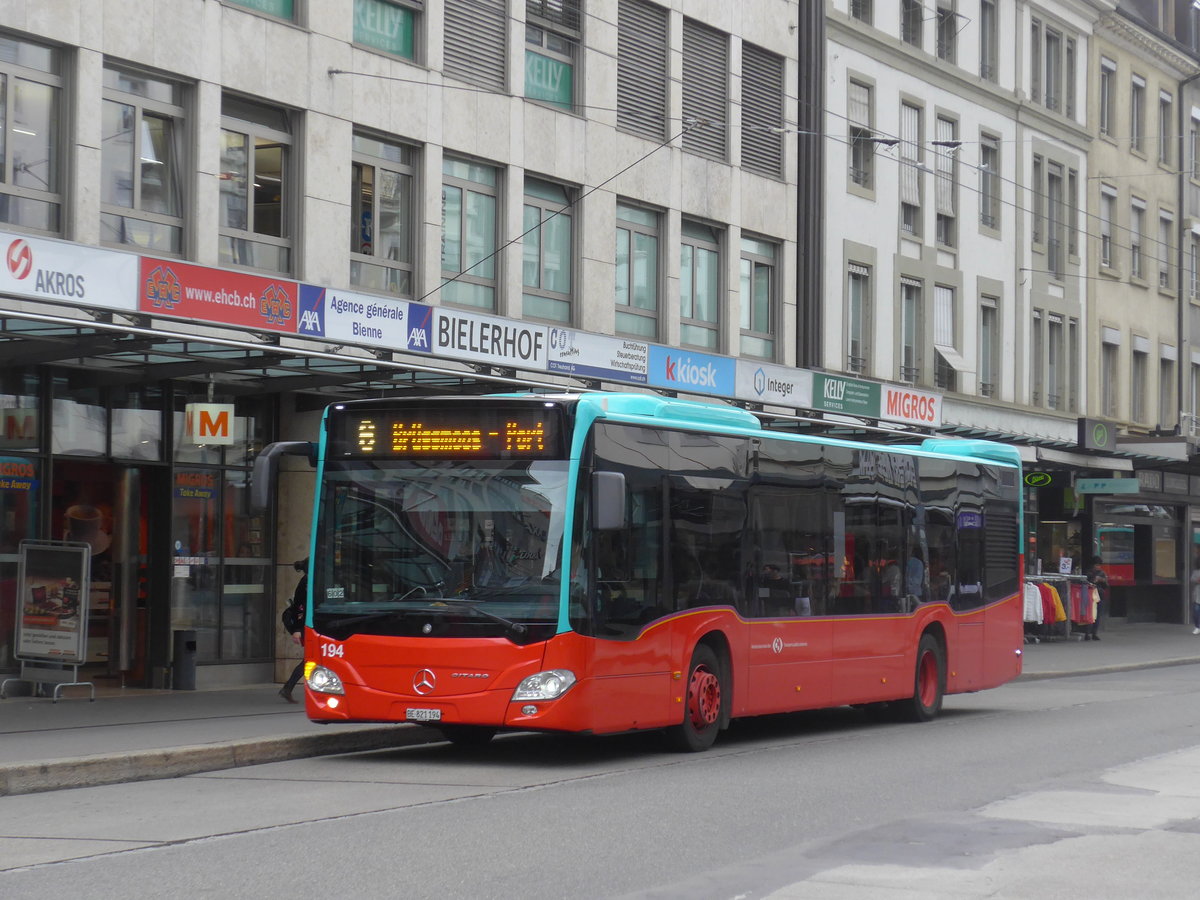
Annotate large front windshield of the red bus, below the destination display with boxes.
[313,460,568,643]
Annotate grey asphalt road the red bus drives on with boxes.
[0,666,1200,900]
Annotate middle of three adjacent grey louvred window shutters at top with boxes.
[683,19,730,160]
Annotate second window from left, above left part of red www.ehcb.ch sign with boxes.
[100,66,185,254]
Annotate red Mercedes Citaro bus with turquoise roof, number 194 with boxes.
[254,392,1022,750]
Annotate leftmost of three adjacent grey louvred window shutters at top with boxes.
[617,0,667,140]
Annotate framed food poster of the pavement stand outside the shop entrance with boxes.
[17,541,91,664]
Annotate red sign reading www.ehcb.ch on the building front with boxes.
[138,257,298,334]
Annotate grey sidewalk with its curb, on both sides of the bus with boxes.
[0,624,1200,797]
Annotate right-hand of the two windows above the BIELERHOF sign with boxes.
[521,176,574,323]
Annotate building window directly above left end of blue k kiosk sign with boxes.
[616,203,660,341]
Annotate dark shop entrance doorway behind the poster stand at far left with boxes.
[50,460,160,686]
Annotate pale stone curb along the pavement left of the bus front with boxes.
[0,725,442,797]
